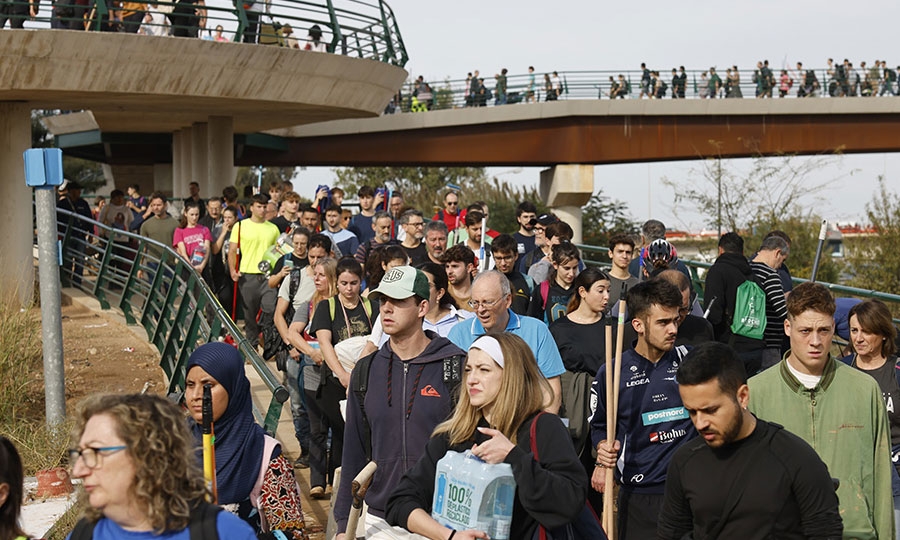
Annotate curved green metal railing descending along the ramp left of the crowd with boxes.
[51,209,288,434]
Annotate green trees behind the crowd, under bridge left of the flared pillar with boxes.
[334,167,545,233]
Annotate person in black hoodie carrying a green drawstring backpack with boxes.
[703,232,765,376]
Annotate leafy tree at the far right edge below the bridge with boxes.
[848,177,900,304]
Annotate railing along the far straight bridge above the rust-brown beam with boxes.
[390,66,896,112]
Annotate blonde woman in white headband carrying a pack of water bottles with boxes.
[386,333,587,540]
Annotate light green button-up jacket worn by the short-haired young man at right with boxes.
[749,353,894,540]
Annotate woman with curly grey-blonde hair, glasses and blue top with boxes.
[69,394,256,540]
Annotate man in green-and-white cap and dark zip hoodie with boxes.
[334,266,466,540]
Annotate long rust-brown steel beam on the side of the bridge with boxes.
[248,112,900,166]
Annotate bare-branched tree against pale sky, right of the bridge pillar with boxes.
[662,150,855,232]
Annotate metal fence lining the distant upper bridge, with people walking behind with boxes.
[393,67,897,112]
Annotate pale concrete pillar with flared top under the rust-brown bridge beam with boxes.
[540,165,594,244]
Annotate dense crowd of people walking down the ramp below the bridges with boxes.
[47,178,900,539]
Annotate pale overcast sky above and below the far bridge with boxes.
[297,0,900,230]
